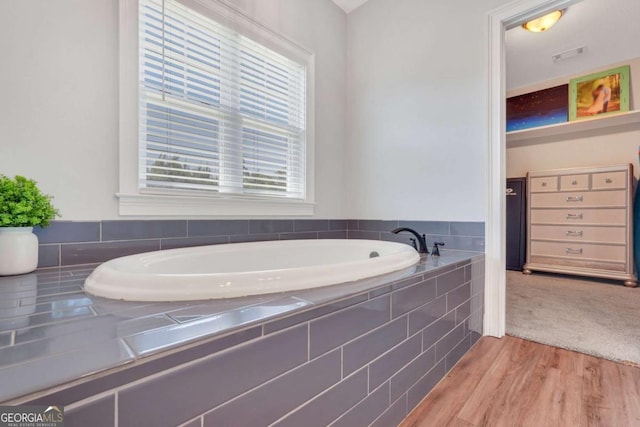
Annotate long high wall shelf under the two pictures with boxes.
[506,110,640,148]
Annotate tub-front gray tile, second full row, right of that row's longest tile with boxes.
[342,316,407,375]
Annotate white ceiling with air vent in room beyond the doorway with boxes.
[506,0,640,89]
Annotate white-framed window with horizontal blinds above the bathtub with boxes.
[119,0,313,215]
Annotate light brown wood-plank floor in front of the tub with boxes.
[400,336,640,427]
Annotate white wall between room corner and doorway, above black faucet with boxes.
[347,0,507,221]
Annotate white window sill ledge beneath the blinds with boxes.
[116,193,315,218]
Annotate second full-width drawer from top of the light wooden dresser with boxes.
[529,209,627,227]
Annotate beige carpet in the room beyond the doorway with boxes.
[507,271,640,365]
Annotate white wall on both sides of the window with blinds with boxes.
[0,0,347,220]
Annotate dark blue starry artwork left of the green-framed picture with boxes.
[507,84,569,132]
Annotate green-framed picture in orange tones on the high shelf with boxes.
[569,65,629,121]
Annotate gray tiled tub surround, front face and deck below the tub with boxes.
[0,251,484,427]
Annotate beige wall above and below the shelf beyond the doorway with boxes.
[507,58,640,177]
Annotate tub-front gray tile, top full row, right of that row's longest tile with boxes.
[309,296,390,357]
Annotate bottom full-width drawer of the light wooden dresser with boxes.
[530,240,627,262]
